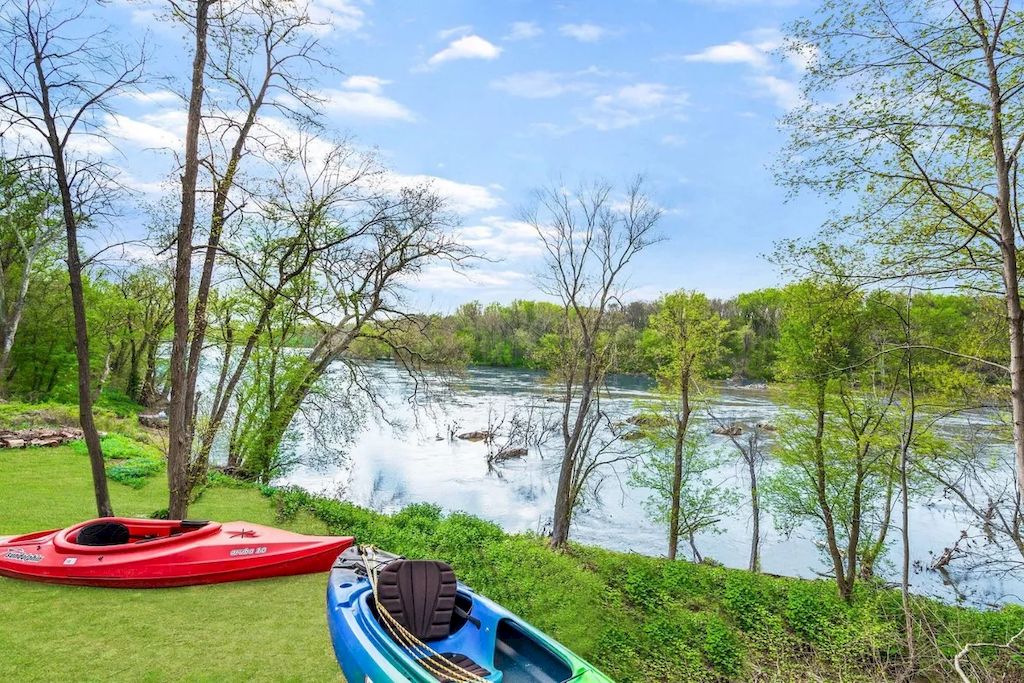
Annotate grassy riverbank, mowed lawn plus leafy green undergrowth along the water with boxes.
[0,413,1024,682]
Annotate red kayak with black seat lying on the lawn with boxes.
[0,517,352,588]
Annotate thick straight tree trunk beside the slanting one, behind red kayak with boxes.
[167,0,211,519]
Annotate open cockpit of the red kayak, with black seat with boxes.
[53,517,220,554]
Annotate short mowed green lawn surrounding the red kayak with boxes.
[0,447,344,681]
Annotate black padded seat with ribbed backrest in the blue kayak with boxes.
[377,559,490,683]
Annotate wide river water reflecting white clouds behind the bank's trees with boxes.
[275,362,1024,605]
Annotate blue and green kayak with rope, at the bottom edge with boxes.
[327,547,612,683]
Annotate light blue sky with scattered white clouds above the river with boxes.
[102,0,826,310]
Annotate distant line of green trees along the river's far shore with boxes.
[339,288,1006,383]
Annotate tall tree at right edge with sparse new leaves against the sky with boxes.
[780,0,1024,496]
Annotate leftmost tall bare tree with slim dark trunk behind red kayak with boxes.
[0,0,143,516]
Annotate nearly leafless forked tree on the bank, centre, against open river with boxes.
[524,178,662,548]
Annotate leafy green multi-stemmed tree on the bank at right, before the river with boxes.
[769,282,900,600]
